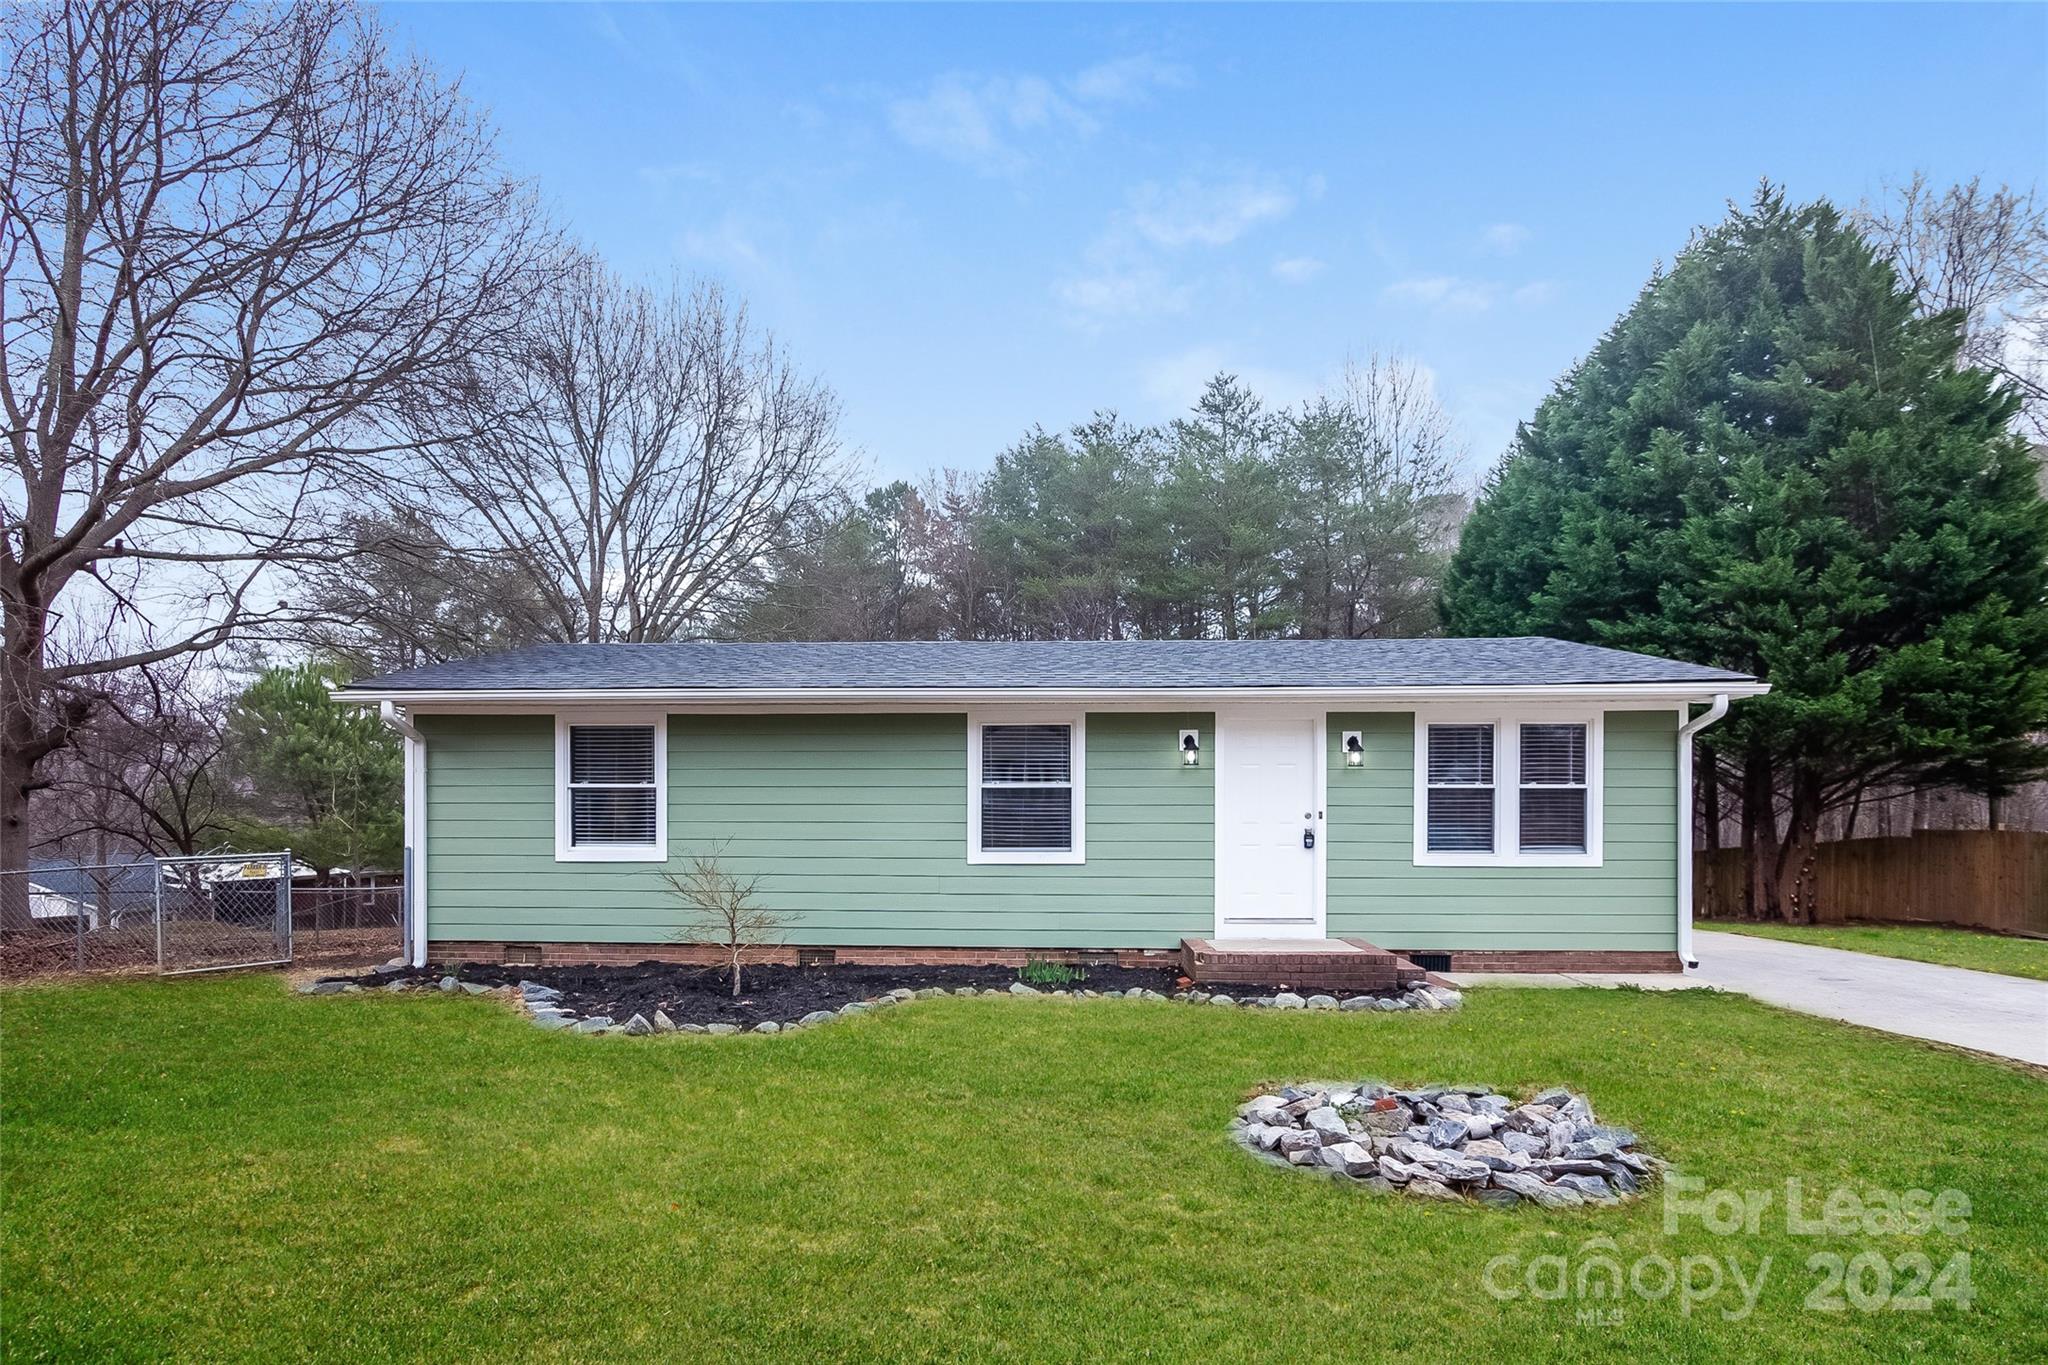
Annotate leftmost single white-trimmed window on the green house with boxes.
[555,712,668,862]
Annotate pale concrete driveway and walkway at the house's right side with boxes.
[1456,929,2048,1066]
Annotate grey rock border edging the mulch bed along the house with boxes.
[299,976,1464,1038]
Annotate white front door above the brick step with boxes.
[1217,712,1323,939]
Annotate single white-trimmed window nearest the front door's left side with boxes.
[967,712,1087,864]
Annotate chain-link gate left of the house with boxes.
[156,849,291,976]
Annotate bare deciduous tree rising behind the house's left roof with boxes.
[395,260,842,643]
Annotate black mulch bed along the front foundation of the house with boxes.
[339,962,1392,1027]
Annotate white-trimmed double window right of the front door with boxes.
[1415,706,1604,868]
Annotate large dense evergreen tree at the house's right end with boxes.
[1444,186,2048,919]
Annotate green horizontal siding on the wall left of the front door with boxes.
[422,712,1214,948]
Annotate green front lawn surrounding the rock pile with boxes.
[0,976,2048,1361]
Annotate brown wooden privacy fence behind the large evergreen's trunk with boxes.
[1692,829,2048,935]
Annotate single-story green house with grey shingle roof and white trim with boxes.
[340,639,1765,970]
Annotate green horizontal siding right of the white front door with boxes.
[1329,710,1677,952]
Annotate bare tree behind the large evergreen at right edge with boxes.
[1853,172,2048,440]
